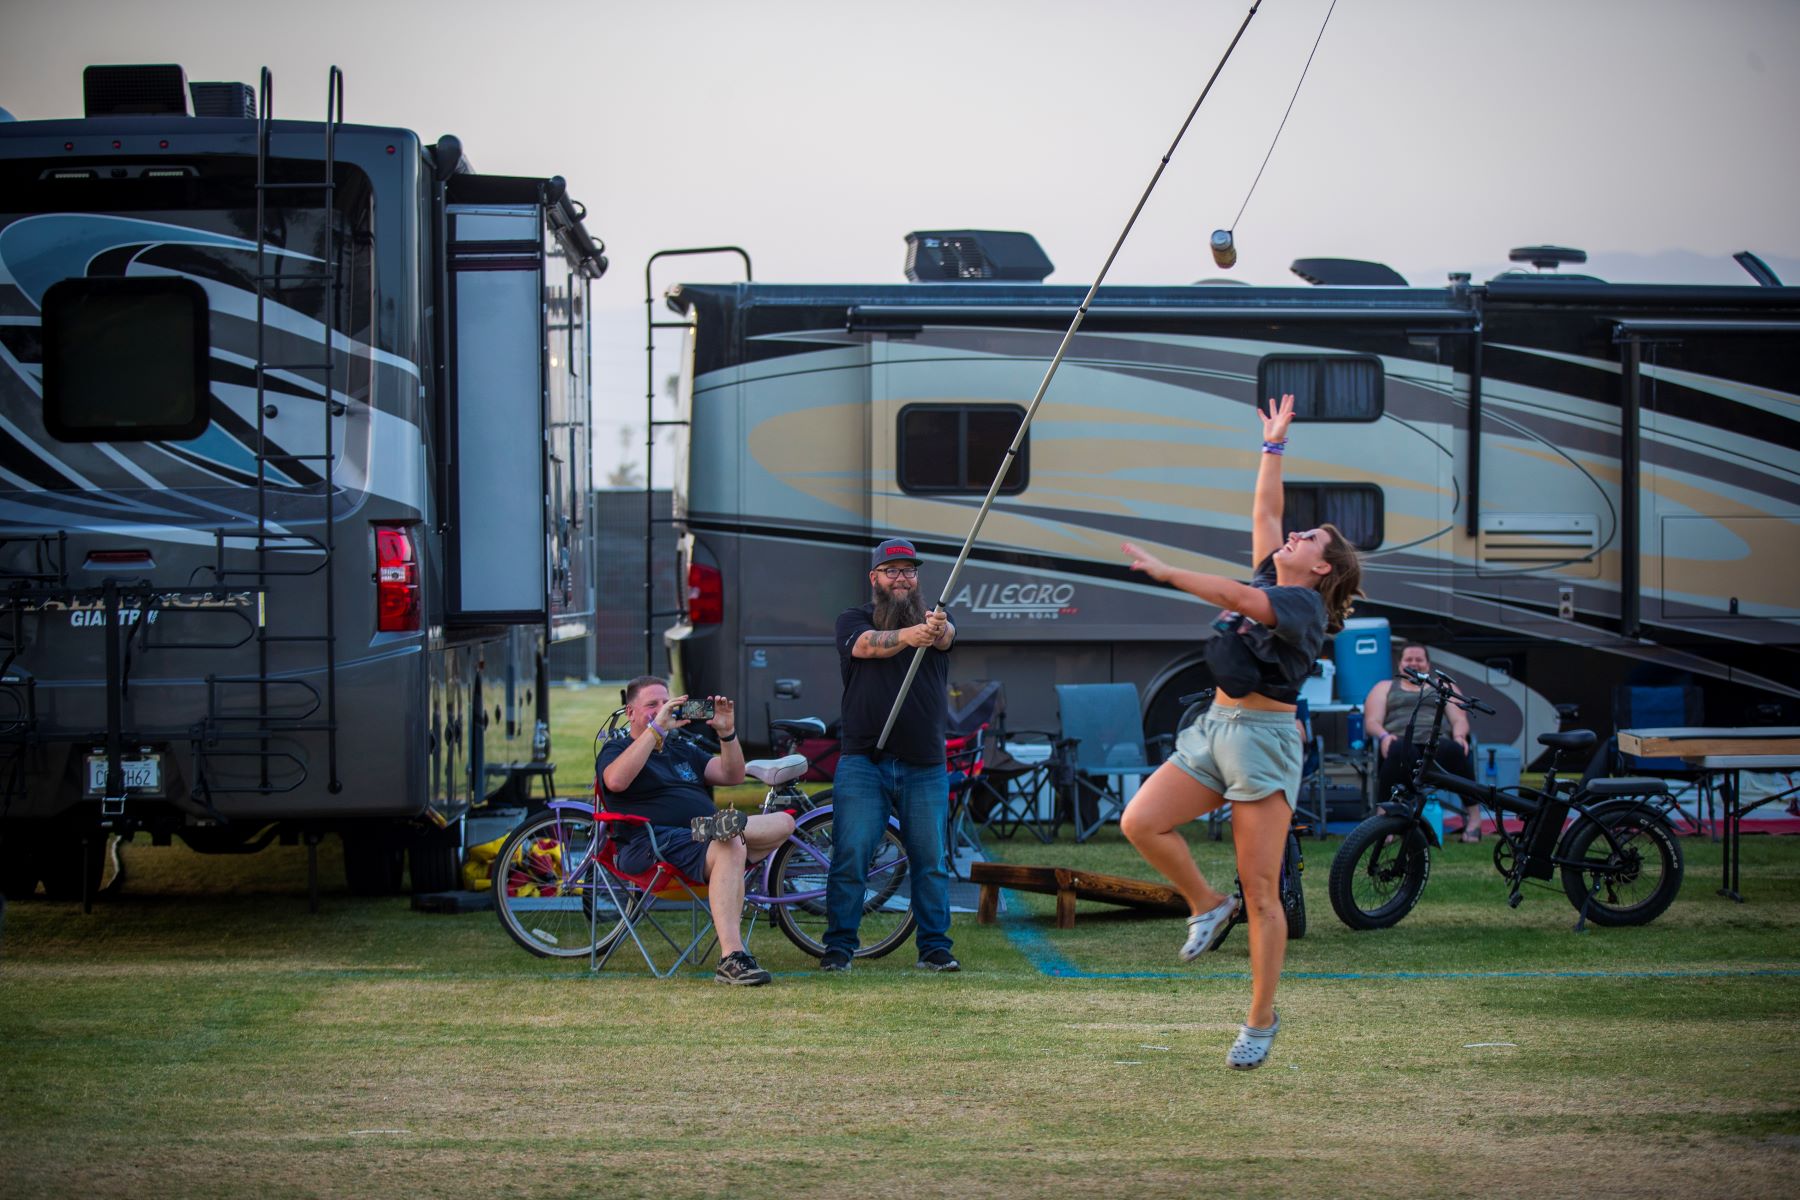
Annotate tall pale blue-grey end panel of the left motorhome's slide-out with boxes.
[446,176,549,624]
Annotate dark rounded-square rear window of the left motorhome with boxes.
[43,275,211,441]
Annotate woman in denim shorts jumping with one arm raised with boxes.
[1120,396,1363,1070]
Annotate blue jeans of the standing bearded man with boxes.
[824,754,950,955]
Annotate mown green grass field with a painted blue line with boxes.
[0,690,1800,1198]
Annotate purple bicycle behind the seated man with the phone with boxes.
[493,723,914,961]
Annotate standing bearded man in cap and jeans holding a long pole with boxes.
[819,538,961,972]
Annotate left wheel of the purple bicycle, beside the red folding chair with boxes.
[493,811,623,959]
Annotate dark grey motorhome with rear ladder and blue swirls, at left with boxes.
[0,67,607,898]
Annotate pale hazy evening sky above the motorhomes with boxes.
[0,0,1800,480]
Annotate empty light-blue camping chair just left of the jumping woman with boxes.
[1057,684,1170,842]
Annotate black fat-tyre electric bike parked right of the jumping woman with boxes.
[1330,671,1683,930]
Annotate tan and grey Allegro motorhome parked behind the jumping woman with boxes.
[666,236,1800,759]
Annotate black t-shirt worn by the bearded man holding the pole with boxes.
[837,603,950,766]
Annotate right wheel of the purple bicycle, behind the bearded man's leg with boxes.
[769,808,914,959]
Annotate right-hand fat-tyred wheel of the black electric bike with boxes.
[1557,808,1683,925]
